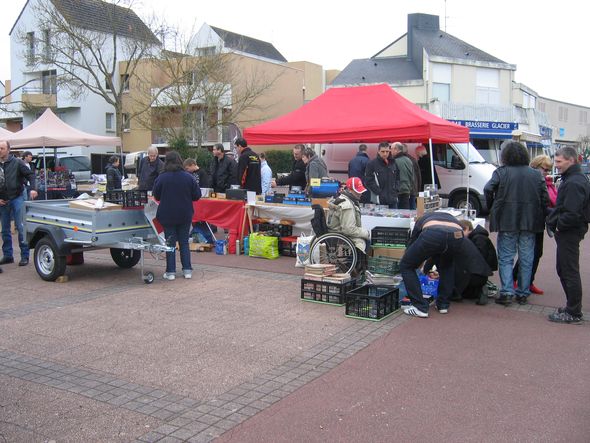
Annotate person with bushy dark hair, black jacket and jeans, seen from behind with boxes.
[484,141,549,305]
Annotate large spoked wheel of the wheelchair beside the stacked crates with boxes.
[309,233,358,273]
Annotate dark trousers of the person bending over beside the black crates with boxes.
[400,227,464,312]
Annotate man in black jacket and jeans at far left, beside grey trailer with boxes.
[0,141,37,266]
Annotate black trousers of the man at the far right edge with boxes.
[555,231,585,315]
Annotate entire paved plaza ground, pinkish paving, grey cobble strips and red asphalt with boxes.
[0,234,590,442]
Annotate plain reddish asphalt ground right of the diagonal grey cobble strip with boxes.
[216,236,590,443]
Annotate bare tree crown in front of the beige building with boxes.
[140,29,281,151]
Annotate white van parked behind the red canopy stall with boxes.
[321,143,496,214]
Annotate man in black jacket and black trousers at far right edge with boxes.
[547,147,590,323]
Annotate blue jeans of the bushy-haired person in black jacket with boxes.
[498,231,535,297]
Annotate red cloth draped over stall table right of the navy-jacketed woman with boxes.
[193,198,248,254]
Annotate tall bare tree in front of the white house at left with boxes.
[19,0,160,136]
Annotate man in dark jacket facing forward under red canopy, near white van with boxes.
[364,142,400,208]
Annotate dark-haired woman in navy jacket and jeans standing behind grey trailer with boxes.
[153,151,201,280]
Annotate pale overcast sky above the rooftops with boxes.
[0,0,590,106]
